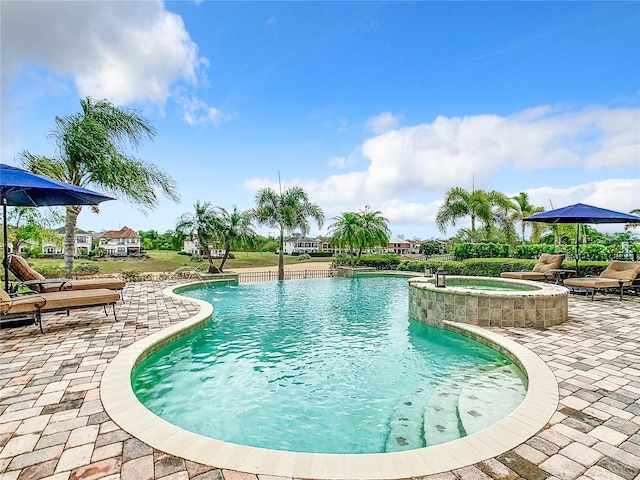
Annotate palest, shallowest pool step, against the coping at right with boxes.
[457,365,527,435]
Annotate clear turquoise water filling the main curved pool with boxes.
[132,277,526,453]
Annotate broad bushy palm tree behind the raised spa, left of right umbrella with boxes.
[436,187,514,243]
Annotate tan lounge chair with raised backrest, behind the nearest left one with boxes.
[7,255,125,301]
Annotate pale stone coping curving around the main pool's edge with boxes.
[100,282,559,480]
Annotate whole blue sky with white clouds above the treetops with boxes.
[0,0,640,238]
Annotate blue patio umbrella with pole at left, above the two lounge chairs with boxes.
[0,163,115,290]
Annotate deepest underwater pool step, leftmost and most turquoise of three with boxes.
[385,388,429,452]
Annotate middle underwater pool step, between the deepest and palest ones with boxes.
[423,376,473,446]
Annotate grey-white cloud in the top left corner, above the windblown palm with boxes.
[2,1,208,104]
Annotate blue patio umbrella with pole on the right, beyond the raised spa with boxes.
[523,203,640,271]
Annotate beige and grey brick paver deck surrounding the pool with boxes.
[0,282,640,480]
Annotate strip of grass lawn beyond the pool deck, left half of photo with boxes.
[29,250,333,274]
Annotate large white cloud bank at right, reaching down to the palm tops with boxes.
[245,107,640,236]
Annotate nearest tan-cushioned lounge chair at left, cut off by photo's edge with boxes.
[0,288,120,333]
